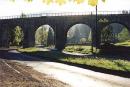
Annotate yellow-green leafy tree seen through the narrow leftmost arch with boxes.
[13,26,24,46]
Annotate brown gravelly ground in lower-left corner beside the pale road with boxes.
[0,51,68,87]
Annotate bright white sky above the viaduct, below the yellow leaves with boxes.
[0,0,130,16]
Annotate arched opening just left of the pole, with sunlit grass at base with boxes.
[64,24,92,54]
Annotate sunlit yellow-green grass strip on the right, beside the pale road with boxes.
[61,57,130,72]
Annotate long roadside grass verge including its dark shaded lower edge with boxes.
[19,48,130,77]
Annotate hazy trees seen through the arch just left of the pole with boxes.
[67,24,92,44]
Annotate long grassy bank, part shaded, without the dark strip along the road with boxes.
[19,48,130,72]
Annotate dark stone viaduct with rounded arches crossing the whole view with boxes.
[0,14,130,50]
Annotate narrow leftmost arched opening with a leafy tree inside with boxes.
[9,26,24,48]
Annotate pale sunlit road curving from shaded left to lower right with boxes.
[0,50,130,87]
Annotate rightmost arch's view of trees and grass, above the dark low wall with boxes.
[101,23,130,46]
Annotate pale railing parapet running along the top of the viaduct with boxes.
[0,11,130,20]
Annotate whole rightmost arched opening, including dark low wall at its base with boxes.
[100,23,130,55]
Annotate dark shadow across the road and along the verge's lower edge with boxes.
[0,50,130,78]
